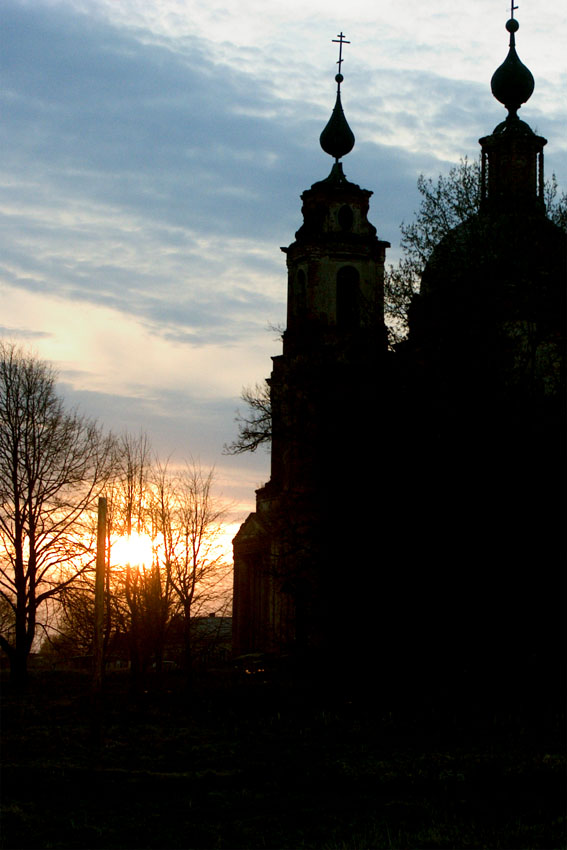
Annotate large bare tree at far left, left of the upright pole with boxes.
[0,343,112,685]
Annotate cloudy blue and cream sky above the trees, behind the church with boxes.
[0,0,567,522]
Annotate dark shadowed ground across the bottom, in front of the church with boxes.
[2,669,565,850]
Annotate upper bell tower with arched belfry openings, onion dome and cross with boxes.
[282,33,389,355]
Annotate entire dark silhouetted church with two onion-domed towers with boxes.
[233,18,567,704]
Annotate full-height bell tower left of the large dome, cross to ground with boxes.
[234,38,389,652]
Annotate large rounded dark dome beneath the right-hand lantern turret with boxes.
[408,213,567,396]
